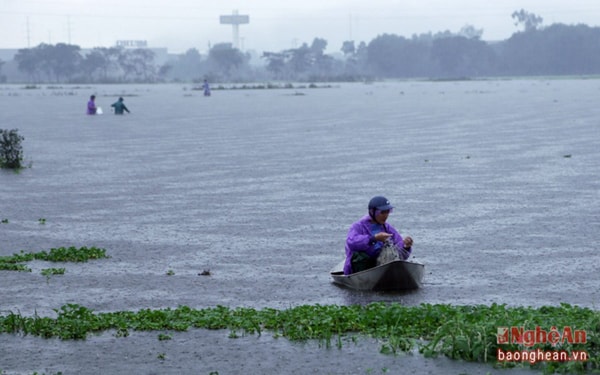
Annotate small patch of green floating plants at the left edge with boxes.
[0,246,108,272]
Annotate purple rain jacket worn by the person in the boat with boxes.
[344,215,412,275]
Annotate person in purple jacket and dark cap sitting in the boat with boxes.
[344,196,413,275]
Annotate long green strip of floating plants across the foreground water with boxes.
[0,302,600,372]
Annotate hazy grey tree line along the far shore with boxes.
[0,10,600,83]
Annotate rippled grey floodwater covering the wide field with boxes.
[0,79,600,375]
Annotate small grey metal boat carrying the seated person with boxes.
[330,260,425,291]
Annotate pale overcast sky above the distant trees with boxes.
[0,0,600,53]
